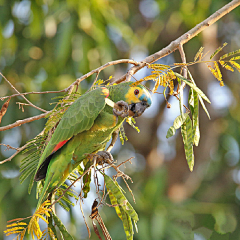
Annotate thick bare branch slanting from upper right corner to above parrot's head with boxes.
[113,0,240,83]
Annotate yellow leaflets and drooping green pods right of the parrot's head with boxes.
[139,43,240,171]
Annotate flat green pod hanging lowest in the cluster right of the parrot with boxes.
[181,116,194,172]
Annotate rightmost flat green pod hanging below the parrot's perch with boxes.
[104,174,138,221]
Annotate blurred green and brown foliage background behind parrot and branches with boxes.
[0,0,240,240]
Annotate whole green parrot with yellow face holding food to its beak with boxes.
[35,82,152,209]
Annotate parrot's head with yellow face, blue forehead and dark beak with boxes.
[110,82,152,117]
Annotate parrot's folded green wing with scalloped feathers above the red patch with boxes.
[37,88,106,170]
